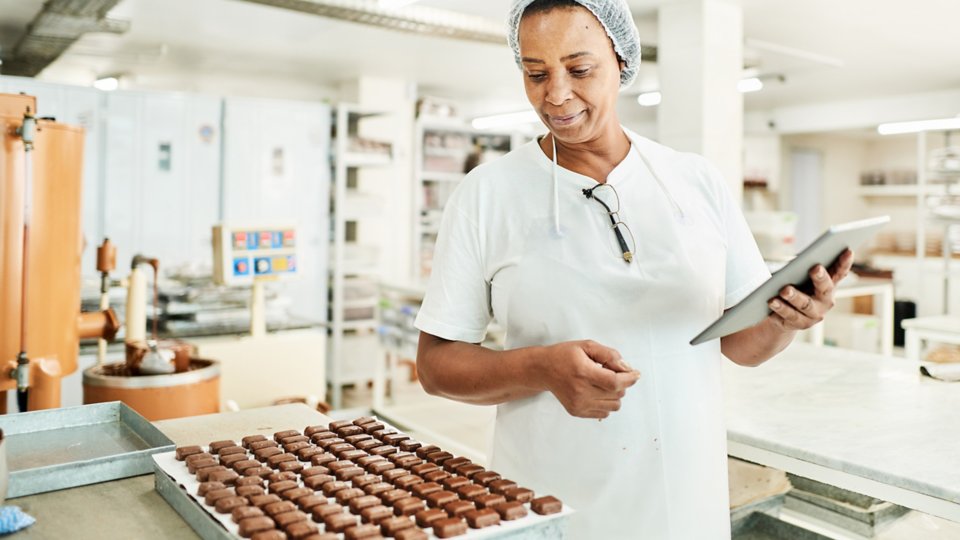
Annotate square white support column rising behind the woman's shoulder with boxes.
[658,0,743,201]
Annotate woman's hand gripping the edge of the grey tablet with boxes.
[767,249,853,330]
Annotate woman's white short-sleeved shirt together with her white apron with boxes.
[416,131,769,540]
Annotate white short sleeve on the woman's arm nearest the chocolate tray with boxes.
[414,185,492,343]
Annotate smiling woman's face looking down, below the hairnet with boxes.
[519,7,620,144]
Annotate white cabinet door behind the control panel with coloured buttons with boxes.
[223,99,330,321]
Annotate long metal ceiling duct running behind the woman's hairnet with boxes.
[245,0,657,62]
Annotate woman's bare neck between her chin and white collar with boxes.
[540,123,630,184]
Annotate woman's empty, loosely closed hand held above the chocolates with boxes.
[541,340,640,419]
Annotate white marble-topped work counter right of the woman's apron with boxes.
[724,343,960,522]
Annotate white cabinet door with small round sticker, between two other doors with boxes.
[103,92,221,269]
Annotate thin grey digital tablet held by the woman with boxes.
[690,216,890,345]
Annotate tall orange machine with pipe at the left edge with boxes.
[0,94,117,412]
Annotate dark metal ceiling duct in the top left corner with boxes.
[2,0,130,77]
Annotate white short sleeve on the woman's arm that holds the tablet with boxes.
[710,160,770,310]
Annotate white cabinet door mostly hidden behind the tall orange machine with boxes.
[0,77,103,276]
